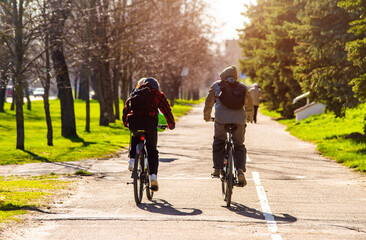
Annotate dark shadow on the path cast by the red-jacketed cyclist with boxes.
[138,199,202,216]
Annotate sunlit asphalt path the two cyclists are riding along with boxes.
[0,104,366,240]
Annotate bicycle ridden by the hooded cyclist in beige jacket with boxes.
[221,124,239,207]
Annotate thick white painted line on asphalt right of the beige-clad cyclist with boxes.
[252,172,282,240]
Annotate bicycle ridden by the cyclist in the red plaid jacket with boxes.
[131,125,168,204]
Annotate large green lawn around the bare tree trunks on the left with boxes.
[0,100,197,165]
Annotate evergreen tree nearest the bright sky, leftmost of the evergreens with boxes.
[240,0,301,117]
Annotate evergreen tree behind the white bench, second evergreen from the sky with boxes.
[291,0,357,117]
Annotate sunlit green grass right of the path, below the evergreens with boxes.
[263,104,366,172]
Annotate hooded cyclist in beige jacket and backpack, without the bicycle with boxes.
[203,66,253,186]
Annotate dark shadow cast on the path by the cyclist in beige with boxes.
[228,202,297,223]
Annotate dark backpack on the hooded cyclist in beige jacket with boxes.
[218,81,246,110]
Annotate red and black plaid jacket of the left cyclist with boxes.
[122,88,175,128]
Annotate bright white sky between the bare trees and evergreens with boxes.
[205,0,256,41]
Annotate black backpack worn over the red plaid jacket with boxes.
[130,86,151,112]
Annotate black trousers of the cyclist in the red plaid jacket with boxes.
[128,116,159,174]
